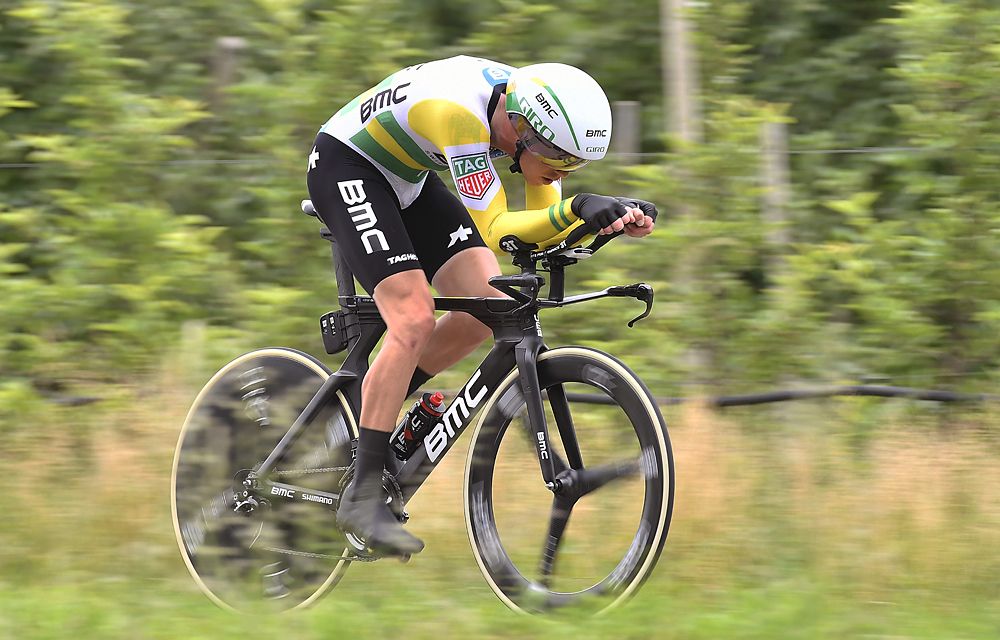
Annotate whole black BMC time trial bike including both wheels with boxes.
[171,201,674,612]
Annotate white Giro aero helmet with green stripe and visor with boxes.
[507,62,611,171]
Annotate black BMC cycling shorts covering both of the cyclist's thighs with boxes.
[306,133,486,293]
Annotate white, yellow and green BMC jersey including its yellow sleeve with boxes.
[320,56,577,253]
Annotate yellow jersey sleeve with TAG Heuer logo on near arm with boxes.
[409,99,579,253]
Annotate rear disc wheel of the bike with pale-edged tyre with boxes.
[171,348,357,610]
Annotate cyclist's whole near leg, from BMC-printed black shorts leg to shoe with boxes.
[307,133,434,554]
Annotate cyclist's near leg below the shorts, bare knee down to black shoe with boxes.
[337,270,434,554]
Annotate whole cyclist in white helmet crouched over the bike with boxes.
[307,56,656,555]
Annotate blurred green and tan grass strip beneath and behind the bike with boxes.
[0,362,1000,639]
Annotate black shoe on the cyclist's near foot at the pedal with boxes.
[337,482,424,557]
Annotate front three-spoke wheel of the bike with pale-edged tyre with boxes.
[465,347,674,613]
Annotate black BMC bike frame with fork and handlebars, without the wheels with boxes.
[254,222,653,508]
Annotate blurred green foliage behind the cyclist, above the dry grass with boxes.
[0,0,1000,400]
